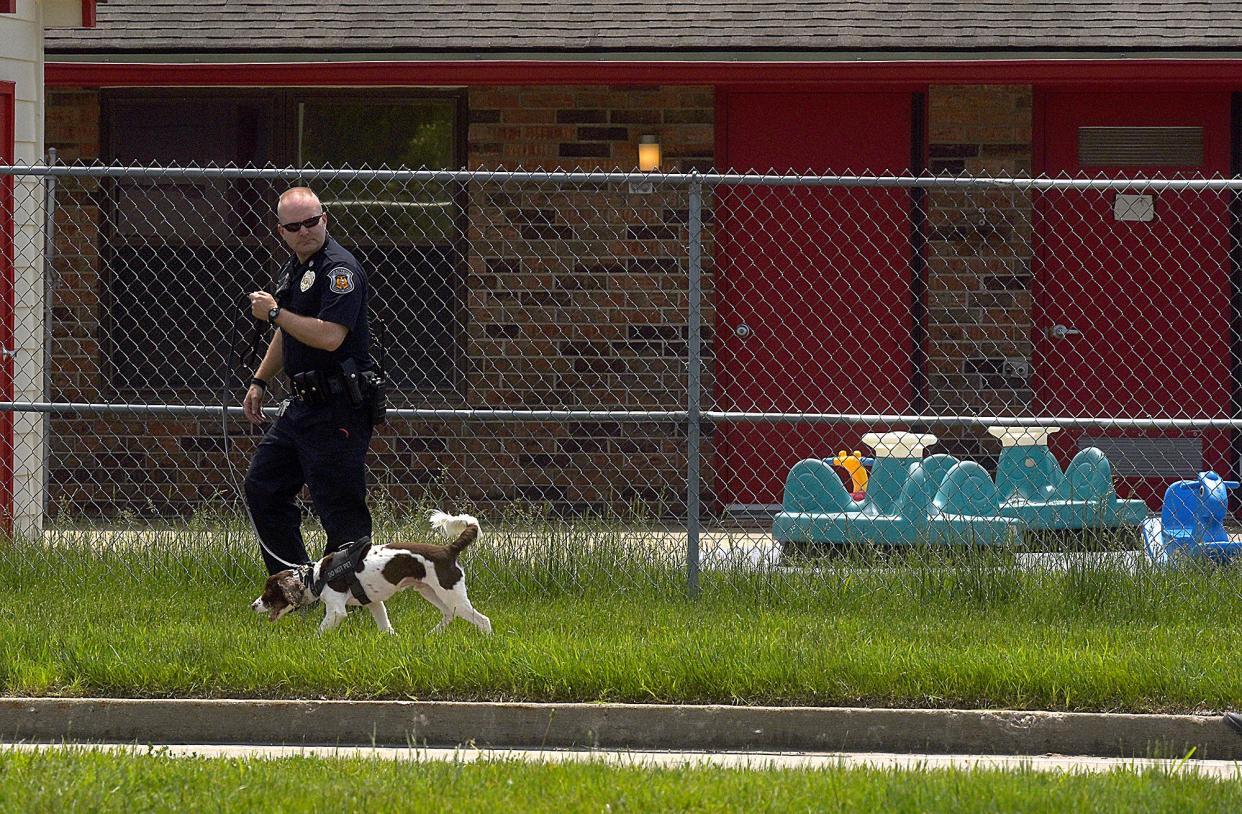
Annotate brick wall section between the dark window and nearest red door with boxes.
[462,87,714,512]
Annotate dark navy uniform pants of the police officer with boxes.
[246,399,373,574]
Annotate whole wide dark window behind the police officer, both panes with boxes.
[101,91,461,394]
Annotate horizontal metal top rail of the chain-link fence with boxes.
[7,164,1242,191]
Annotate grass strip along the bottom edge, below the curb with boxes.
[0,748,1242,814]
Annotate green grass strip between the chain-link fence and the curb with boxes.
[0,529,1242,711]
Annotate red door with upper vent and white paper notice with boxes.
[1033,92,1230,508]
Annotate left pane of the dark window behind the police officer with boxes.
[101,96,276,394]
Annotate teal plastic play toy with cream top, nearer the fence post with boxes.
[773,432,1021,546]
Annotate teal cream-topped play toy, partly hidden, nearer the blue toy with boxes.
[987,426,1148,531]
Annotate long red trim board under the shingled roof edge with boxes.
[43,56,1242,87]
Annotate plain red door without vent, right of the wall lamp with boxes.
[714,92,913,510]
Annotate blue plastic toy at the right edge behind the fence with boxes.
[1143,471,1242,564]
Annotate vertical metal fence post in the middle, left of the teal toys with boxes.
[686,170,703,597]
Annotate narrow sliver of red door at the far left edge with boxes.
[0,82,16,532]
